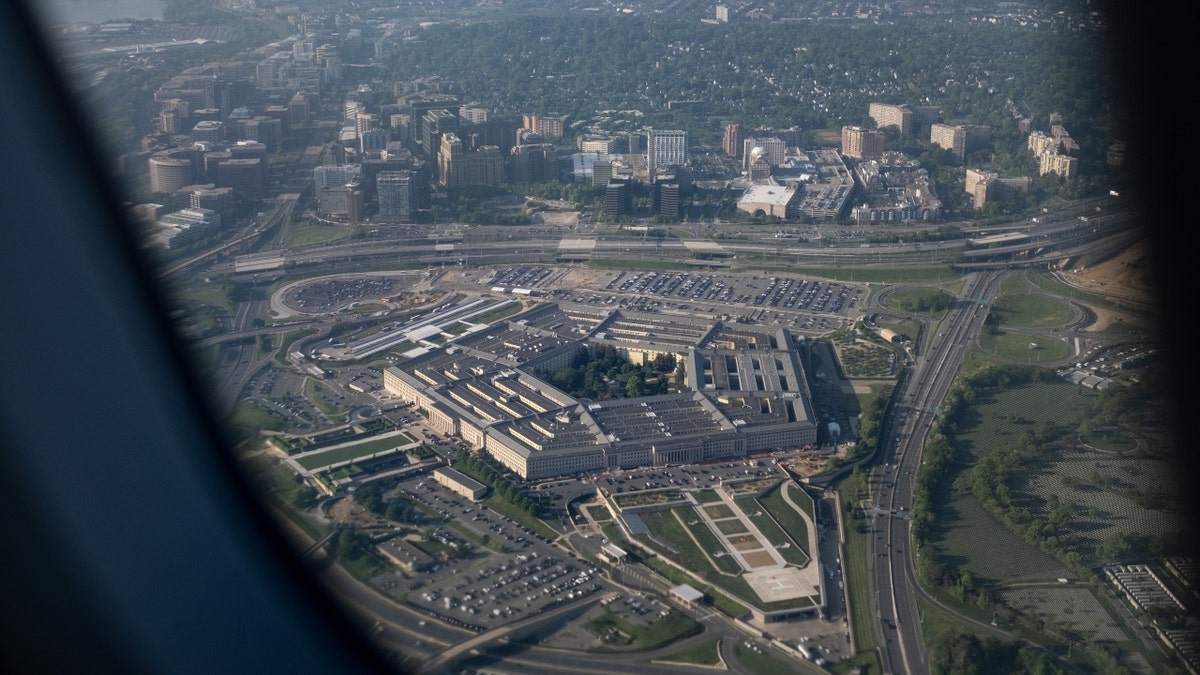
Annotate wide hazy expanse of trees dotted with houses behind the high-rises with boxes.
[391,14,1120,157]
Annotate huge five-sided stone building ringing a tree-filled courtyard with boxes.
[384,304,817,479]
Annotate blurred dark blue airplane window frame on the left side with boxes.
[0,1,394,673]
